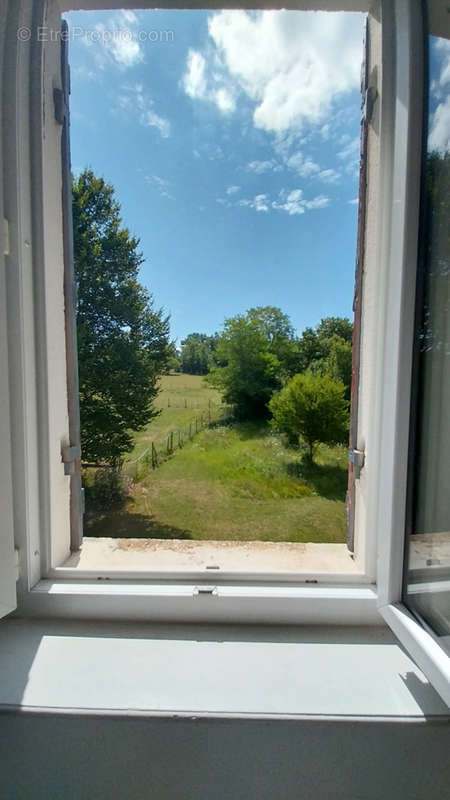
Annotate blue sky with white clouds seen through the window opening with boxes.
[67,11,363,340]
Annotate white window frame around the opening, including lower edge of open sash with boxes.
[0,0,450,703]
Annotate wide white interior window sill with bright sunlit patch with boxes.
[0,619,448,722]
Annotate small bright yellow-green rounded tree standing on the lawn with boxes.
[269,372,349,460]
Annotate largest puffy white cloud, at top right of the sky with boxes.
[199,11,363,135]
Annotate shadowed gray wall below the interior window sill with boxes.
[0,712,450,800]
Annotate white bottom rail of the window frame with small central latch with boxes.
[16,577,383,625]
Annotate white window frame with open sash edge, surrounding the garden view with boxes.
[0,0,450,702]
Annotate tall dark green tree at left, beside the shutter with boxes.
[72,169,169,465]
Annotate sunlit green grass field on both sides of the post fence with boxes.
[85,375,347,542]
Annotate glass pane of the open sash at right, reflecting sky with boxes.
[406,29,450,634]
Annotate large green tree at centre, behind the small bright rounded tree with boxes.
[207,315,281,419]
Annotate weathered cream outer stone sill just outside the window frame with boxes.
[49,537,364,583]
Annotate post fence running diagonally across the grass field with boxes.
[123,403,233,480]
